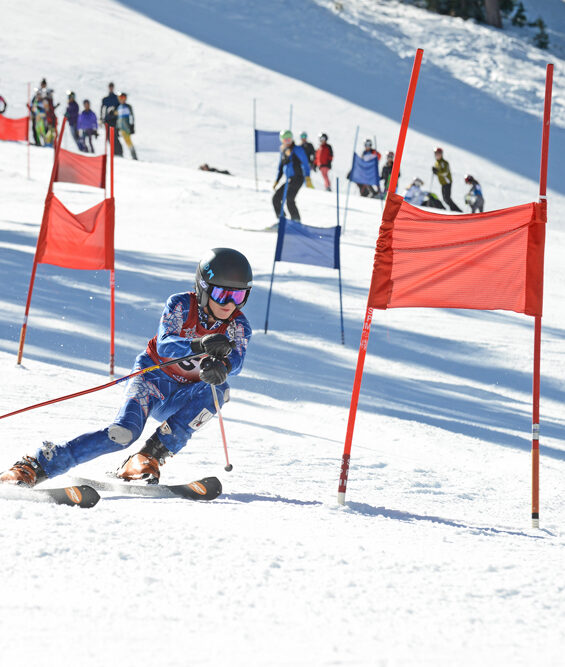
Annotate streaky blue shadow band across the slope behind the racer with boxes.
[0,230,565,460]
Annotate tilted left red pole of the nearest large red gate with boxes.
[337,49,424,505]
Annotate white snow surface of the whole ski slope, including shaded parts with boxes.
[0,0,565,667]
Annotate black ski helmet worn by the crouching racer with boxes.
[196,248,253,308]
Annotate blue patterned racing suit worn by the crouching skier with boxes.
[34,292,251,477]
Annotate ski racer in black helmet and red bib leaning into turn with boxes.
[0,248,253,486]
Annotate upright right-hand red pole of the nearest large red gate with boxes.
[532,64,553,528]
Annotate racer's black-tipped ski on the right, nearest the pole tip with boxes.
[69,477,222,500]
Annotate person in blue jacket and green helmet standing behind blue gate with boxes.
[273,130,314,222]
